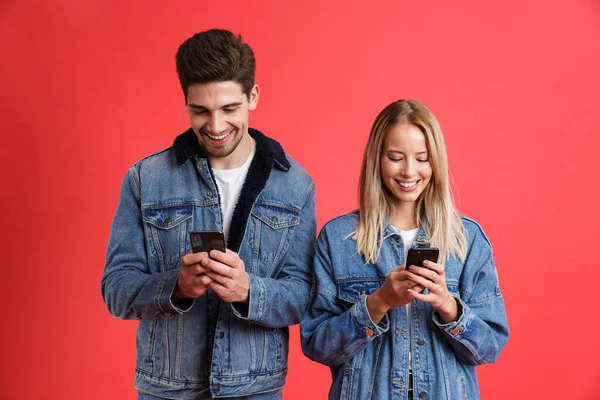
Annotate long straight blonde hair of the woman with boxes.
[352,100,467,263]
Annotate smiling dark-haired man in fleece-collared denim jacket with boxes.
[102,30,316,400]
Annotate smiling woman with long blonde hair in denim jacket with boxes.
[301,100,508,400]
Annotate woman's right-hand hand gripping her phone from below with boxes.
[407,260,459,324]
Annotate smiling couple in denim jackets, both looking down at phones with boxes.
[101,30,508,400]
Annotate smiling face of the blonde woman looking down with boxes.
[381,123,432,206]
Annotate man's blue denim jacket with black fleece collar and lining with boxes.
[101,129,316,399]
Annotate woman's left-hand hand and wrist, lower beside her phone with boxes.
[367,265,424,324]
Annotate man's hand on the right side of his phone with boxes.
[202,249,250,304]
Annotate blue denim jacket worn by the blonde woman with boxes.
[300,213,508,400]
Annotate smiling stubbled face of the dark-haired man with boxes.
[186,81,259,167]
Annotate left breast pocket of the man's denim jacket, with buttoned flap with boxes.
[142,205,193,271]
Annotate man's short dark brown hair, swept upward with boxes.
[175,29,256,103]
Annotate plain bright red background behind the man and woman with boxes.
[0,0,600,399]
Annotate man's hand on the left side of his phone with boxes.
[173,252,212,302]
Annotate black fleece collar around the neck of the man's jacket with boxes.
[173,128,290,171]
